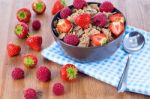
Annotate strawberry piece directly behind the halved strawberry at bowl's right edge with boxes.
[109,13,125,23]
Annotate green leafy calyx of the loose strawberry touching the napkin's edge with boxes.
[66,66,77,80]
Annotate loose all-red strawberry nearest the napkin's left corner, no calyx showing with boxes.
[26,35,42,51]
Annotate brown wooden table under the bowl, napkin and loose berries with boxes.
[0,0,150,99]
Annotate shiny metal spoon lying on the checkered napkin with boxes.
[117,31,145,92]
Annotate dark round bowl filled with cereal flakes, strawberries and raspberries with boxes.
[51,0,126,61]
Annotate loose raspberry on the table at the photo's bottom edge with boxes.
[24,88,37,99]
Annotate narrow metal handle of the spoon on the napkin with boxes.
[117,54,131,92]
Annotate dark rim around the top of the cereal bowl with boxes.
[51,2,127,49]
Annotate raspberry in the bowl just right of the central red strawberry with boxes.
[93,13,107,27]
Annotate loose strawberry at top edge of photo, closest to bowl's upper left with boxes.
[52,0,66,15]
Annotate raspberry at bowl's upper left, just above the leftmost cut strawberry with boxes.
[60,7,72,19]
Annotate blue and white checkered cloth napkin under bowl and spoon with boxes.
[42,26,150,95]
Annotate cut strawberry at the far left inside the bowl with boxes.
[56,19,72,33]
